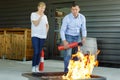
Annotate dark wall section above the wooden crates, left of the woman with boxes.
[0,0,43,28]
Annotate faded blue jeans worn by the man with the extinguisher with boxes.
[64,35,80,72]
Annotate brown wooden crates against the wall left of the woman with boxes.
[0,28,33,61]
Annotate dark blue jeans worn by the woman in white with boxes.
[32,37,45,66]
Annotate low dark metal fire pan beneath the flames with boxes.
[22,72,106,80]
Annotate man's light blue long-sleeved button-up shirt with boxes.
[60,13,87,40]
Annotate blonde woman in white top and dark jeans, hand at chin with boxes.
[31,2,49,72]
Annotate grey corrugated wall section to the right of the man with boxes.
[77,0,120,64]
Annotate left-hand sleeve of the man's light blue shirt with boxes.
[60,17,67,41]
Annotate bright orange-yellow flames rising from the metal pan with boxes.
[62,47,100,80]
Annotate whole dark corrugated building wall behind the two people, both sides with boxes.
[0,0,120,64]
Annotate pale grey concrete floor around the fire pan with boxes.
[0,59,120,80]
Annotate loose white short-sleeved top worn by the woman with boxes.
[31,12,48,39]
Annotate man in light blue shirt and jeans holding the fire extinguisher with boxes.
[60,4,87,72]
